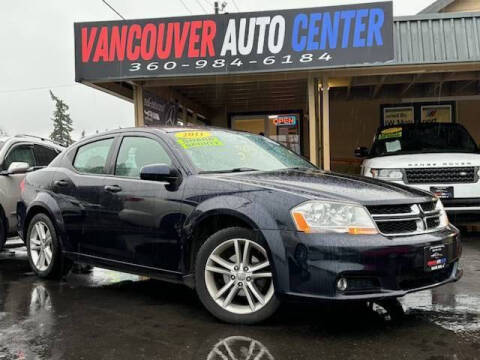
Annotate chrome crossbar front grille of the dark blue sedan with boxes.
[367,201,441,236]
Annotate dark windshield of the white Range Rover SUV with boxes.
[370,124,478,157]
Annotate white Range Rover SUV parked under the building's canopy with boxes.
[355,123,480,222]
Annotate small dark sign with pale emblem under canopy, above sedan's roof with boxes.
[143,90,178,126]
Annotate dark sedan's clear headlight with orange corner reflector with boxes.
[291,200,378,235]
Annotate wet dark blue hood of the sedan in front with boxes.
[206,169,432,205]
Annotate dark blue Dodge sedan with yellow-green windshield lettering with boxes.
[18,128,462,324]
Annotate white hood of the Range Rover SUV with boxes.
[363,153,480,169]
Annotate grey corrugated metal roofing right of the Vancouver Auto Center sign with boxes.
[390,11,480,66]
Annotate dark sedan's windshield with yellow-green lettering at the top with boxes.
[170,130,315,173]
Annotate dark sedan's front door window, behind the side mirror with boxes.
[115,136,172,178]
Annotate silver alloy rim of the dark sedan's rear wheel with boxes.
[29,221,53,271]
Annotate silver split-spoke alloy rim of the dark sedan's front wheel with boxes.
[205,239,274,314]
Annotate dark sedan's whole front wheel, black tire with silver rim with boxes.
[195,227,280,325]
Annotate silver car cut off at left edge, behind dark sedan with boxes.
[0,135,63,250]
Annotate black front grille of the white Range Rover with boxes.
[405,166,476,184]
